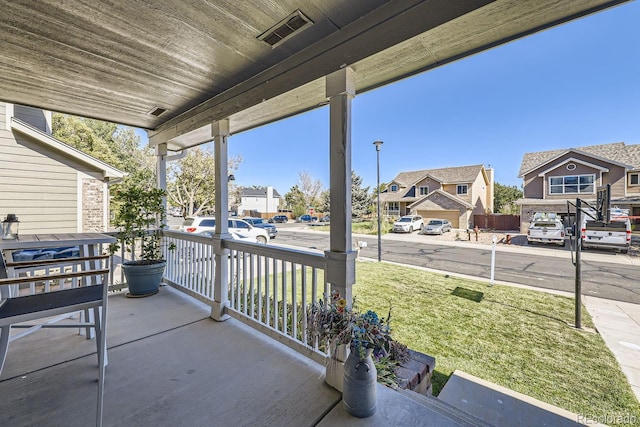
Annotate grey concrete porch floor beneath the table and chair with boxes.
[0,287,481,427]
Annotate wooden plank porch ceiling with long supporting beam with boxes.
[0,0,626,150]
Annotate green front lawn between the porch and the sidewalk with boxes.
[353,262,640,425]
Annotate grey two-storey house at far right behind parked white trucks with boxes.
[517,142,640,232]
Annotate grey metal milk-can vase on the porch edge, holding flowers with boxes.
[342,348,378,418]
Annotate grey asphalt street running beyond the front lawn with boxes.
[272,226,640,304]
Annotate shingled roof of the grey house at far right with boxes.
[518,142,640,178]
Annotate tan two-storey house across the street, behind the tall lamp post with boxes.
[380,165,493,228]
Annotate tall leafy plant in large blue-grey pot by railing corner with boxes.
[111,186,166,297]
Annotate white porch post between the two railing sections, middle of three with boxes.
[211,119,231,322]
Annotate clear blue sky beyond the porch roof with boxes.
[138,1,640,195]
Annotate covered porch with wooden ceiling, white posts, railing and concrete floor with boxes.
[0,0,624,426]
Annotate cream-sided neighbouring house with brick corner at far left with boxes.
[0,102,124,234]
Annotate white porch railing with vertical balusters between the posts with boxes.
[158,230,329,362]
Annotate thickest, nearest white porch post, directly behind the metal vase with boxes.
[325,67,358,305]
